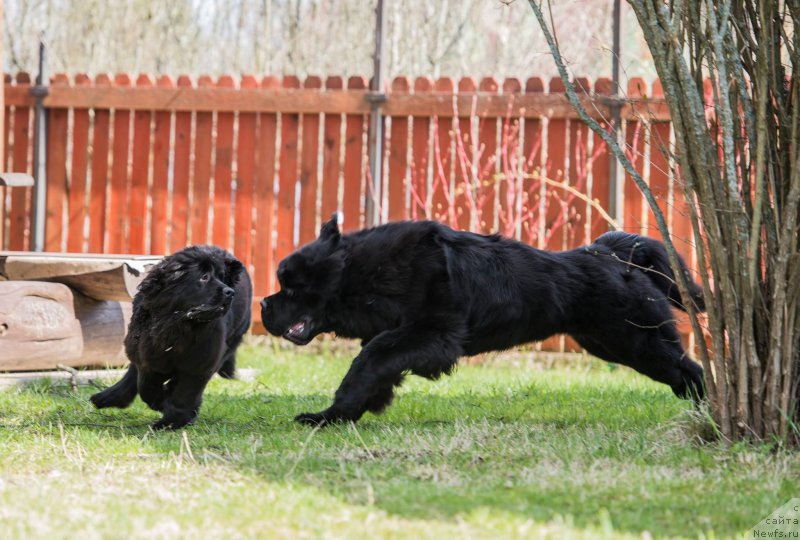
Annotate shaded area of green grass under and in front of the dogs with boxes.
[0,385,764,536]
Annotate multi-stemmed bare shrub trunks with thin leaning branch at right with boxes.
[528,0,800,444]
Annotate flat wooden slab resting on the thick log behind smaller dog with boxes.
[0,251,161,302]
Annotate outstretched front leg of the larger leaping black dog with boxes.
[295,323,462,426]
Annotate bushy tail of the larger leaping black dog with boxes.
[594,231,706,311]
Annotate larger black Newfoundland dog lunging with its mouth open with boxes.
[261,218,704,425]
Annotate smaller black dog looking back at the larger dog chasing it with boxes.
[91,246,253,429]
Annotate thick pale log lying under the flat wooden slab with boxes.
[0,281,131,371]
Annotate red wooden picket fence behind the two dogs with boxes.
[0,73,691,347]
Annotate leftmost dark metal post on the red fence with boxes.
[31,40,49,251]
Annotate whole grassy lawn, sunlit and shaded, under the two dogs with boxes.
[0,345,800,539]
